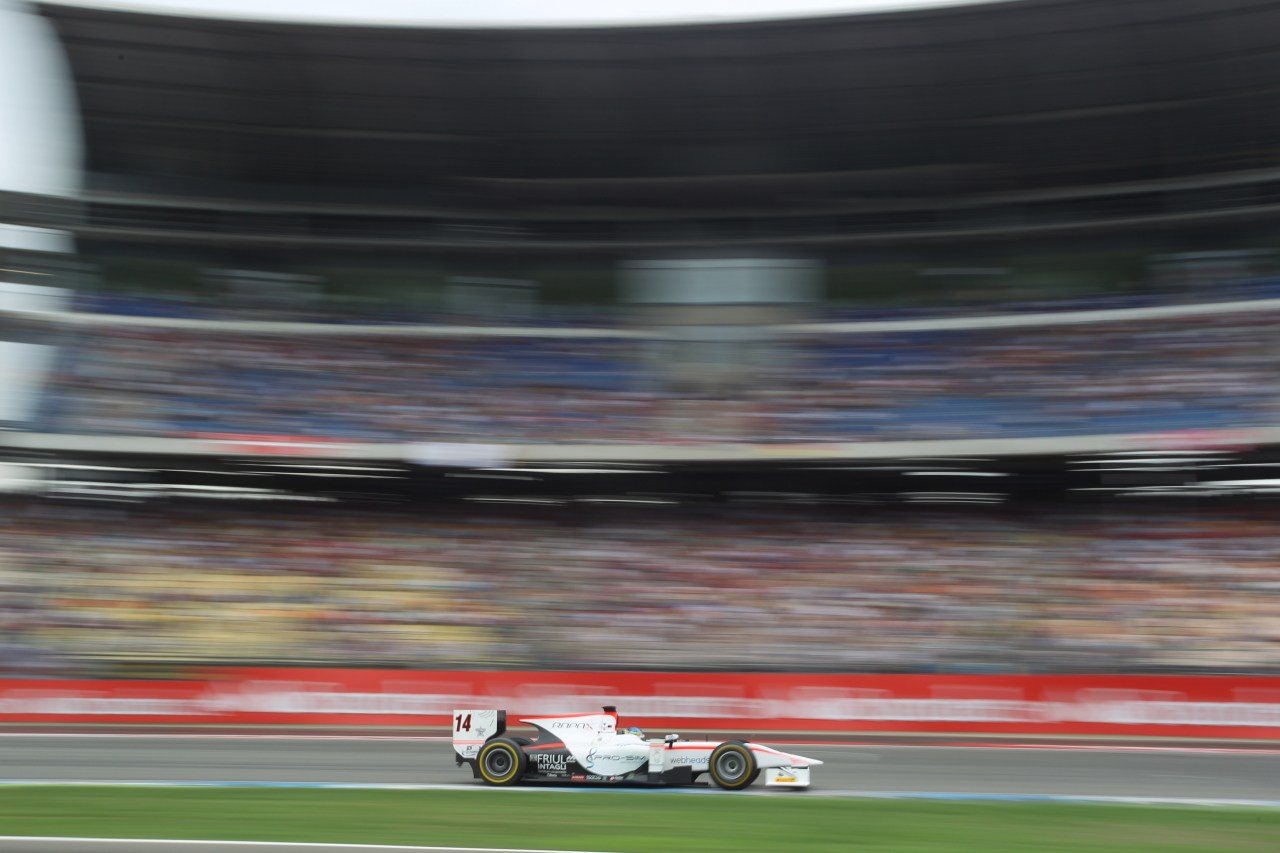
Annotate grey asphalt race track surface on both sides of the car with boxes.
[0,733,1280,802]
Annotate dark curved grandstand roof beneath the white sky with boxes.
[27,0,1280,245]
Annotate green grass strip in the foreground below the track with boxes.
[0,786,1280,853]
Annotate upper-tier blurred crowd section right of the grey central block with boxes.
[754,315,1277,441]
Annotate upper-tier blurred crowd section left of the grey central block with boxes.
[45,332,652,442]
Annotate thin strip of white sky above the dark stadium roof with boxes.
[52,0,1015,26]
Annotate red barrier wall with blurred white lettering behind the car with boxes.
[0,669,1280,739]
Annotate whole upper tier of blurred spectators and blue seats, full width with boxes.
[35,314,1276,443]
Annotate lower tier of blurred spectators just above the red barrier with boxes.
[0,500,1280,672]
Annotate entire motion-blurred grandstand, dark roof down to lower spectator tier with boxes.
[0,0,1280,675]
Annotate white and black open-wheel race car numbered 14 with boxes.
[453,706,822,790]
